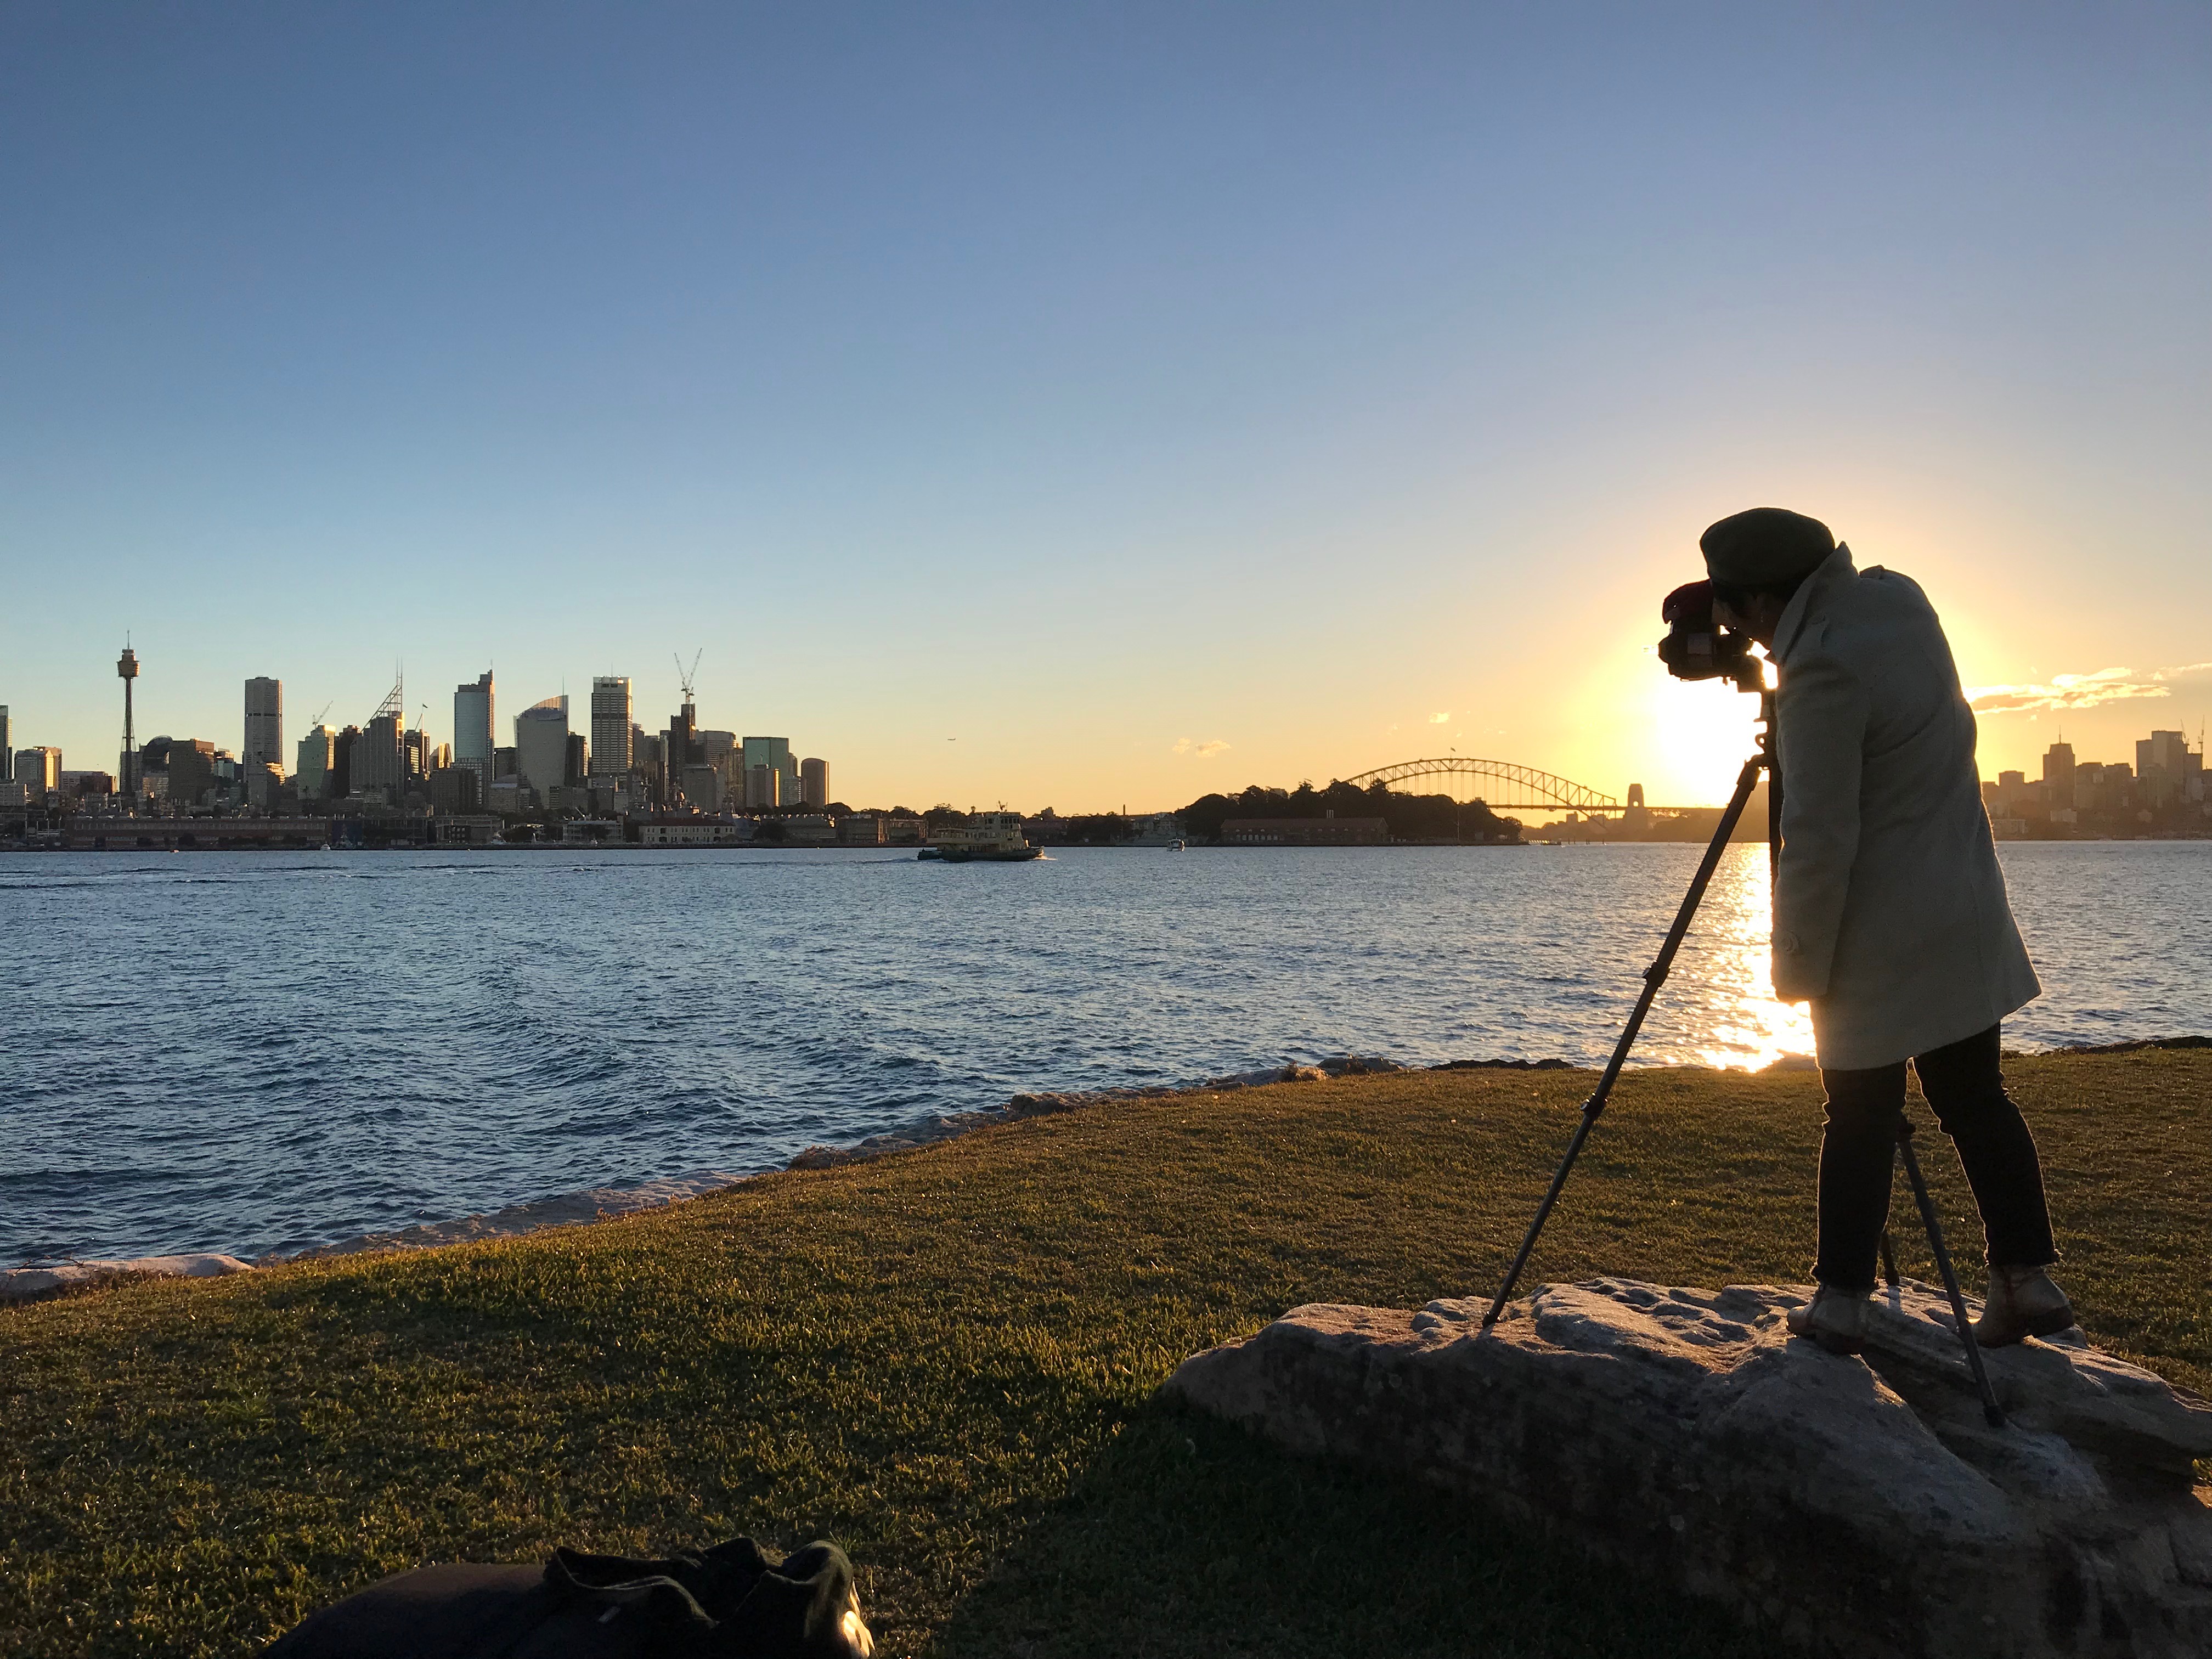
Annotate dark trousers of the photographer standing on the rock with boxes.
[1812,1026,2059,1290]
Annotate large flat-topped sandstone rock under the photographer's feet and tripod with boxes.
[1166,1278,2212,1659]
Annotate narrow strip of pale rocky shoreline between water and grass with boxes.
[13,1035,2212,1303]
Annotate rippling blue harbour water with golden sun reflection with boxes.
[0,843,2212,1265]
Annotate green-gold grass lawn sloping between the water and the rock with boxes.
[0,1051,2212,1659]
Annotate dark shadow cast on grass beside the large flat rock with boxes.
[929,1400,1772,1659]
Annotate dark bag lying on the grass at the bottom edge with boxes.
[263,1537,876,1659]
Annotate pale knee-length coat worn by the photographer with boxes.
[1772,546,2042,1070]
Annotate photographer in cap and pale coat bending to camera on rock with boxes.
[1699,506,2073,1354]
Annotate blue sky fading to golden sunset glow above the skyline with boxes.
[0,0,2212,810]
